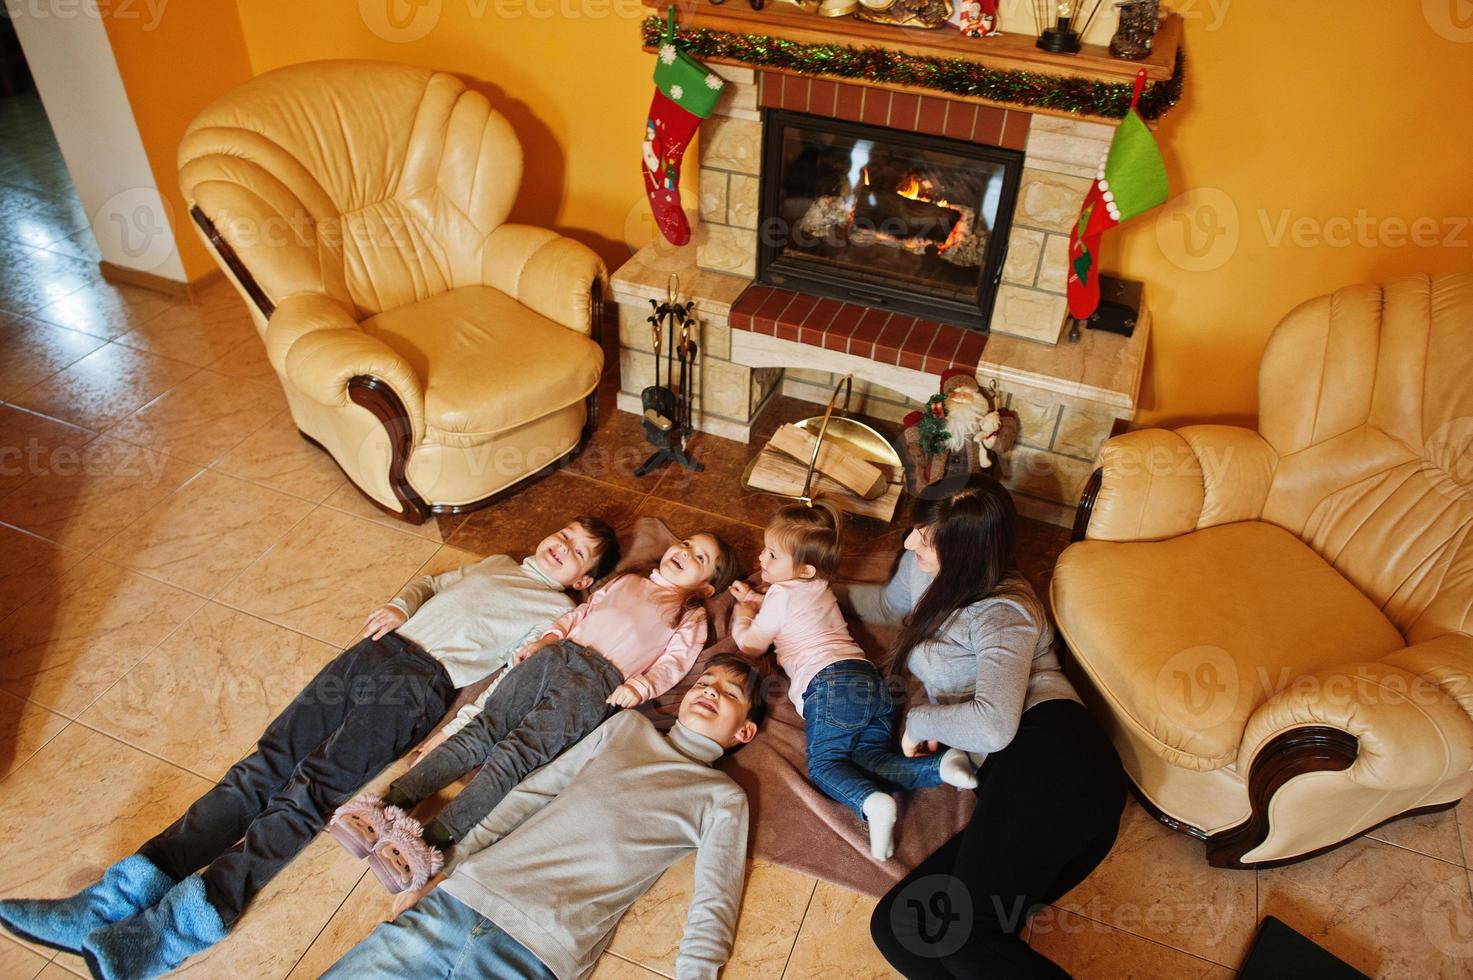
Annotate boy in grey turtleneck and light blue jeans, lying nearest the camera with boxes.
[326,656,762,980]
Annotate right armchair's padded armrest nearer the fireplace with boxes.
[1086,426,1277,541]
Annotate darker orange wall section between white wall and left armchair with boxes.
[103,0,252,280]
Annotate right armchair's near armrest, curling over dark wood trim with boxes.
[1237,662,1473,793]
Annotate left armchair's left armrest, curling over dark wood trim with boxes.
[265,293,424,445]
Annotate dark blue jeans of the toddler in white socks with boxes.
[803,660,941,818]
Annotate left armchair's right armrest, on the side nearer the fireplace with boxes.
[482,224,608,336]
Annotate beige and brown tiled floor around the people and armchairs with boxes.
[0,91,1473,980]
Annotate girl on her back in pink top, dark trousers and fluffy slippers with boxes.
[334,533,737,892]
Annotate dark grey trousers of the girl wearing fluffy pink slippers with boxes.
[384,640,625,847]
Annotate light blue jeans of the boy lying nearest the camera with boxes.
[323,889,552,980]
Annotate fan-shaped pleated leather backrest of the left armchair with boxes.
[178,60,521,317]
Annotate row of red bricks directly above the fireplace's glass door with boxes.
[757,72,1033,150]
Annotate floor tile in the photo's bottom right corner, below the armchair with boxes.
[1258,840,1473,977]
